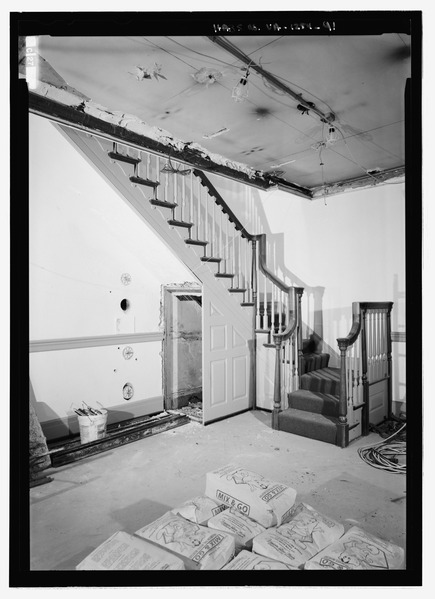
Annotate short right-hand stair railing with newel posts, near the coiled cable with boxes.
[337,302,393,447]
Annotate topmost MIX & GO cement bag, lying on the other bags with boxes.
[205,464,296,528]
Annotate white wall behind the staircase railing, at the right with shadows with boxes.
[212,177,406,402]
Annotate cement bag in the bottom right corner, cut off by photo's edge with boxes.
[304,526,405,570]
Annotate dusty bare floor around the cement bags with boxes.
[30,411,406,571]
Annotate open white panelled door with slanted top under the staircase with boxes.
[202,285,252,424]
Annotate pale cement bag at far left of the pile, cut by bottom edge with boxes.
[76,531,185,570]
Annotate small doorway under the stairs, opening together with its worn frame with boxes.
[162,283,202,422]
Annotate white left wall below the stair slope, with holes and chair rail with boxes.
[29,115,195,438]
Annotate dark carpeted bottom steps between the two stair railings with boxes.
[278,342,340,444]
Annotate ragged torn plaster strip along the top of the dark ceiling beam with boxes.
[29,63,264,179]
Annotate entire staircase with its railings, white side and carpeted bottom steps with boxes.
[56,124,392,447]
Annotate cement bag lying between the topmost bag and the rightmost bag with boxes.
[252,503,344,570]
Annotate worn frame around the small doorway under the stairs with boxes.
[159,282,202,410]
